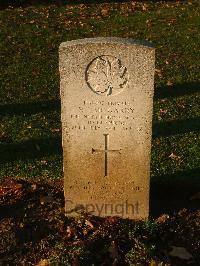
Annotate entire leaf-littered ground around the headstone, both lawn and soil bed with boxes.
[0,0,200,266]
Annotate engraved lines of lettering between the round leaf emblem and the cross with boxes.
[63,99,135,131]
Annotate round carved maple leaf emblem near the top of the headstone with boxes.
[86,55,128,96]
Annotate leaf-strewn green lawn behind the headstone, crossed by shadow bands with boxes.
[0,1,200,214]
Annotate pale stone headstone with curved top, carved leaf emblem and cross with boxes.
[59,38,155,219]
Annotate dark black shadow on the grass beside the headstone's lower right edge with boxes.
[150,168,200,217]
